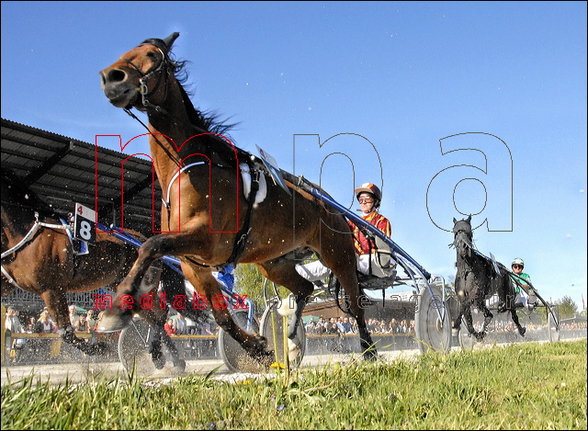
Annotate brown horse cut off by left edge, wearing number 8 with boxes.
[1,169,184,368]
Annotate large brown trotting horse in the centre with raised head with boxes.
[100,33,375,360]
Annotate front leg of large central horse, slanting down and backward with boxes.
[182,262,273,365]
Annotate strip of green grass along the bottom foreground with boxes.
[2,340,586,429]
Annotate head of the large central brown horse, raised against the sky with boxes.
[100,33,180,111]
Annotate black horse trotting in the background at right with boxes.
[450,216,526,341]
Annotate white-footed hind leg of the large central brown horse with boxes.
[257,259,314,340]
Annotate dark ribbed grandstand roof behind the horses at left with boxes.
[1,118,160,233]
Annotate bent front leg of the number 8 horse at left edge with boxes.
[40,290,107,355]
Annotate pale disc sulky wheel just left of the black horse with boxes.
[415,287,452,352]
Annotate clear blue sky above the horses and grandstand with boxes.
[2,2,587,305]
